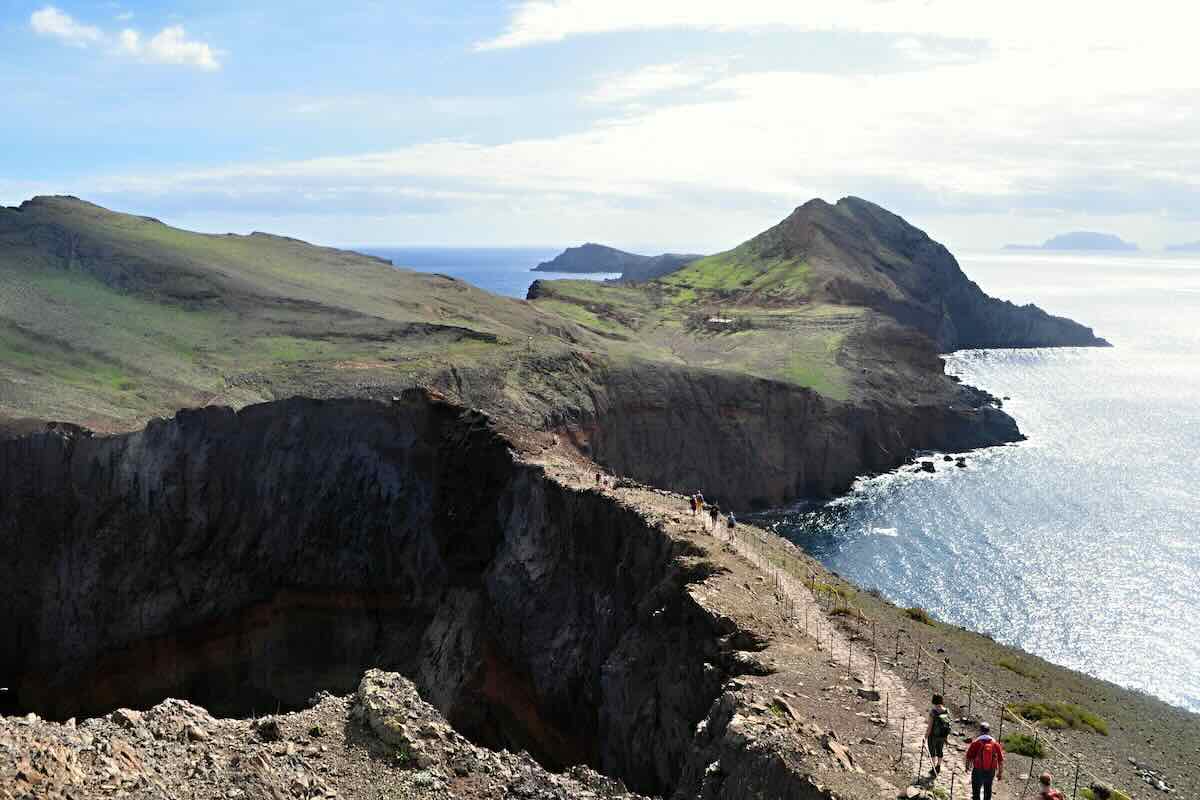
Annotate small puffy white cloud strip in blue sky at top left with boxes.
[29,6,221,71]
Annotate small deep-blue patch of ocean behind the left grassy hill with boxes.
[354,247,620,300]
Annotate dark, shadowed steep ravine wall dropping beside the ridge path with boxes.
[0,392,744,793]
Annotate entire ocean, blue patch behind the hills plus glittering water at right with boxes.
[366,248,1200,711]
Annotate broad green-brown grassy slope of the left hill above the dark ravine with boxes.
[0,198,586,429]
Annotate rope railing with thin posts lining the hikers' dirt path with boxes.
[713,520,1133,800]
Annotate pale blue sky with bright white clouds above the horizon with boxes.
[0,0,1200,252]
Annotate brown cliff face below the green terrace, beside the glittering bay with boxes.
[547,352,1022,510]
